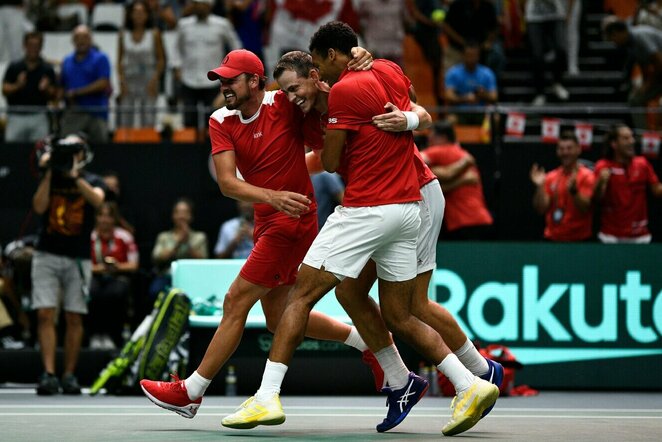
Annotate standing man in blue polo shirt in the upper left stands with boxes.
[60,25,110,143]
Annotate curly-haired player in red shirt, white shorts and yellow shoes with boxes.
[222,22,498,434]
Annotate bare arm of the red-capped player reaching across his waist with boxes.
[213,151,311,218]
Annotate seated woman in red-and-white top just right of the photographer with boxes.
[87,202,138,349]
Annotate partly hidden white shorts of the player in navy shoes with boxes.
[416,180,446,275]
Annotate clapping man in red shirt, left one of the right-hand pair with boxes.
[530,131,595,241]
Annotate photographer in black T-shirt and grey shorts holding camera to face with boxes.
[32,135,105,395]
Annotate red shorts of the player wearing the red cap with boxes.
[239,210,317,288]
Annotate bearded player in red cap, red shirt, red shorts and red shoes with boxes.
[140,49,378,418]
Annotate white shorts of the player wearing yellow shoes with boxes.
[303,203,421,282]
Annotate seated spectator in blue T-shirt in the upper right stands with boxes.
[444,41,498,124]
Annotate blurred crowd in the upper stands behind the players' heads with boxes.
[0,0,662,142]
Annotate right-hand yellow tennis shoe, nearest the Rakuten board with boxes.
[441,378,499,436]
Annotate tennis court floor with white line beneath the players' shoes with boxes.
[0,388,662,442]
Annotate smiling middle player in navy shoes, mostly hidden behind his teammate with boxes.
[274,51,503,431]
